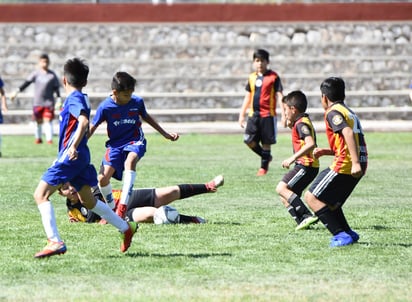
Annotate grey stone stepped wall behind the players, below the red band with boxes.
[0,22,412,122]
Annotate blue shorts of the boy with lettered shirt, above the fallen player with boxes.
[102,139,146,180]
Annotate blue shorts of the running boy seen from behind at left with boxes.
[42,150,97,191]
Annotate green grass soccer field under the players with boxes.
[0,132,412,301]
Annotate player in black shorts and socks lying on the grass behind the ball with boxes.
[59,175,224,223]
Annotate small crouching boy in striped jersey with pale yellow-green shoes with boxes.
[276,91,319,230]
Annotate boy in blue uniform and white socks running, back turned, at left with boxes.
[34,58,137,258]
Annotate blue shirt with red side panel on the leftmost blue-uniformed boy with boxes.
[59,90,90,154]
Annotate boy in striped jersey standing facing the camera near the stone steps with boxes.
[239,49,286,176]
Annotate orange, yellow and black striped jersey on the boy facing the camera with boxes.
[245,69,283,117]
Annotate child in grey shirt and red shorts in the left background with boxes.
[10,54,60,144]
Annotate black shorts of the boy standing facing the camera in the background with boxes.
[243,116,277,145]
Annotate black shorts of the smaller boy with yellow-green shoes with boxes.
[282,164,319,196]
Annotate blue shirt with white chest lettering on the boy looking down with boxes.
[92,95,147,148]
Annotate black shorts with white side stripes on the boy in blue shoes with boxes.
[309,168,361,206]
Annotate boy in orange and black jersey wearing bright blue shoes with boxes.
[305,77,368,247]
